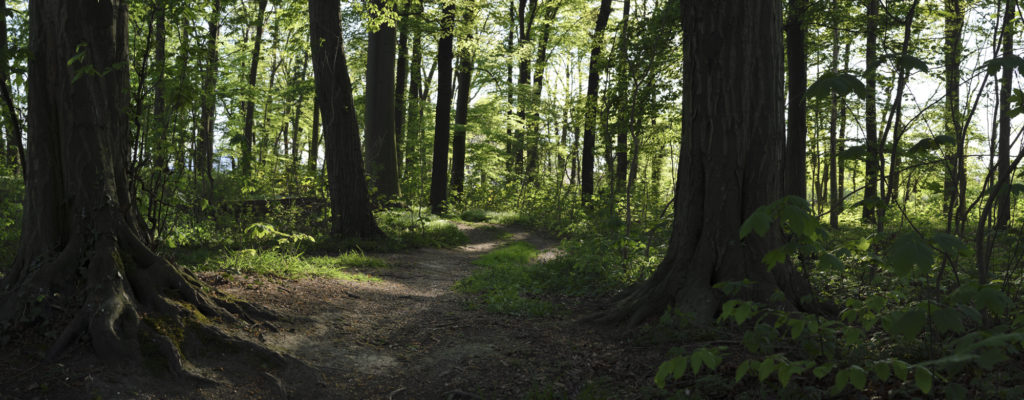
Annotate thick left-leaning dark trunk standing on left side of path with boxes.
[309,0,384,238]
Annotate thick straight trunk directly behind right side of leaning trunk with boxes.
[364,0,399,203]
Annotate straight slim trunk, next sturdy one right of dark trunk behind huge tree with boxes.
[860,0,882,223]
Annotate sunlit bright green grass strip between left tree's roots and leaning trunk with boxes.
[191,249,387,281]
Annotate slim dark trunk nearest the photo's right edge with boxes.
[993,0,1017,229]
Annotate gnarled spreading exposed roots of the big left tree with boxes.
[0,218,298,383]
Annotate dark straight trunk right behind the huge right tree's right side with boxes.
[783,0,807,202]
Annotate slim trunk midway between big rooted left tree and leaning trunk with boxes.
[196,0,220,195]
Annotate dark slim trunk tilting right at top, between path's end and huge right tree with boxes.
[580,0,611,205]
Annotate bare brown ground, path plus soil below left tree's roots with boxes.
[0,224,667,399]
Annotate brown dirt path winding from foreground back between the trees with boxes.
[214,224,664,399]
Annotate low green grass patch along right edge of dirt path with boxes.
[455,241,555,316]
